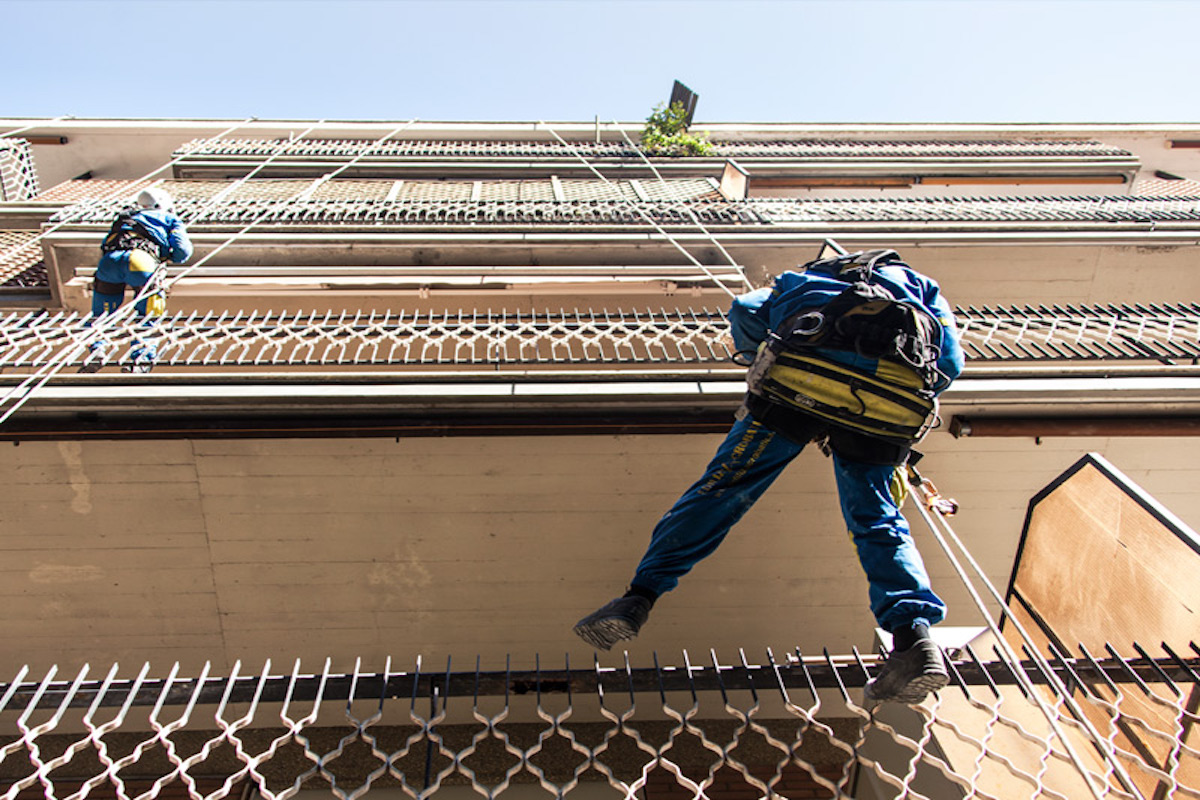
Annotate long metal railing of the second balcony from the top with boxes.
[44,191,1200,225]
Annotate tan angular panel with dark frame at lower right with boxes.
[1002,453,1200,796]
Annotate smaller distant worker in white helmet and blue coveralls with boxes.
[79,188,192,373]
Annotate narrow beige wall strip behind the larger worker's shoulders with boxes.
[46,237,1200,313]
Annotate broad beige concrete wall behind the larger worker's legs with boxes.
[0,433,1200,674]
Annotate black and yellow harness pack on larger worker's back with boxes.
[746,249,942,446]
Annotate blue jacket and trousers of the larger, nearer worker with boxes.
[631,264,962,631]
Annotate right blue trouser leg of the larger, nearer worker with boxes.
[833,450,946,632]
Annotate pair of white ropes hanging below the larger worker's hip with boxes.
[914,481,1144,800]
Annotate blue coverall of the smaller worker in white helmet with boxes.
[91,209,192,317]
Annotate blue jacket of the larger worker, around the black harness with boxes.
[730,264,962,392]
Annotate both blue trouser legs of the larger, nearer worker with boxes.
[632,415,946,631]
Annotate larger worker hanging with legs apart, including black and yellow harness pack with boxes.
[575,248,962,703]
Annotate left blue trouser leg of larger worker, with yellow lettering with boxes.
[631,416,804,595]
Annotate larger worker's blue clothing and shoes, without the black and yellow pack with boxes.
[575,251,962,703]
